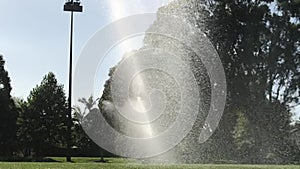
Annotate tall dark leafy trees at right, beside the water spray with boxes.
[208,0,300,163]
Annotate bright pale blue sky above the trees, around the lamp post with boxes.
[0,0,300,121]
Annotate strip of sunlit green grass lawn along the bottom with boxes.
[0,157,300,169]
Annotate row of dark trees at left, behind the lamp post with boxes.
[0,56,102,158]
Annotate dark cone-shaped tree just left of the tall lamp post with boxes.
[26,72,68,156]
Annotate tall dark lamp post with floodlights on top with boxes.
[64,0,82,162]
